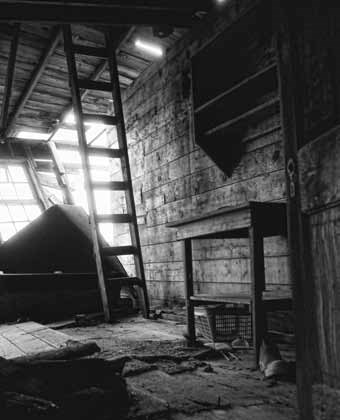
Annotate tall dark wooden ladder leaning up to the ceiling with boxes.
[63,25,149,321]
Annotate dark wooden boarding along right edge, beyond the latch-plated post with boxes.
[298,4,340,420]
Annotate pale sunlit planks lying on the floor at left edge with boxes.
[0,322,80,359]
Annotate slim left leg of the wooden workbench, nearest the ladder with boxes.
[183,239,196,345]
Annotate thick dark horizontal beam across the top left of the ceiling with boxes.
[0,0,205,27]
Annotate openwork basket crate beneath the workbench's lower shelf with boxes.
[195,305,252,344]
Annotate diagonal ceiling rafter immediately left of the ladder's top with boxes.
[4,27,61,136]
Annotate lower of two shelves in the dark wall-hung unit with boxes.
[204,97,280,137]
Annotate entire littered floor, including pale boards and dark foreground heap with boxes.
[0,317,297,420]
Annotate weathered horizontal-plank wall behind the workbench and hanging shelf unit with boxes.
[111,2,290,305]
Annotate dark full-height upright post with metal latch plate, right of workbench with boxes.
[275,0,314,420]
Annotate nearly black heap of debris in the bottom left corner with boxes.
[0,359,129,420]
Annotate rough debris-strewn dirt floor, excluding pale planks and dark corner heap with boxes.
[63,317,297,420]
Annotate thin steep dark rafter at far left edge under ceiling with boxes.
[0,24,20,141]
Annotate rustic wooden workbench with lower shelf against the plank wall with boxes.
[167,202,291,365]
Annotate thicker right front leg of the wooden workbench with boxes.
[249,226,265,368]
